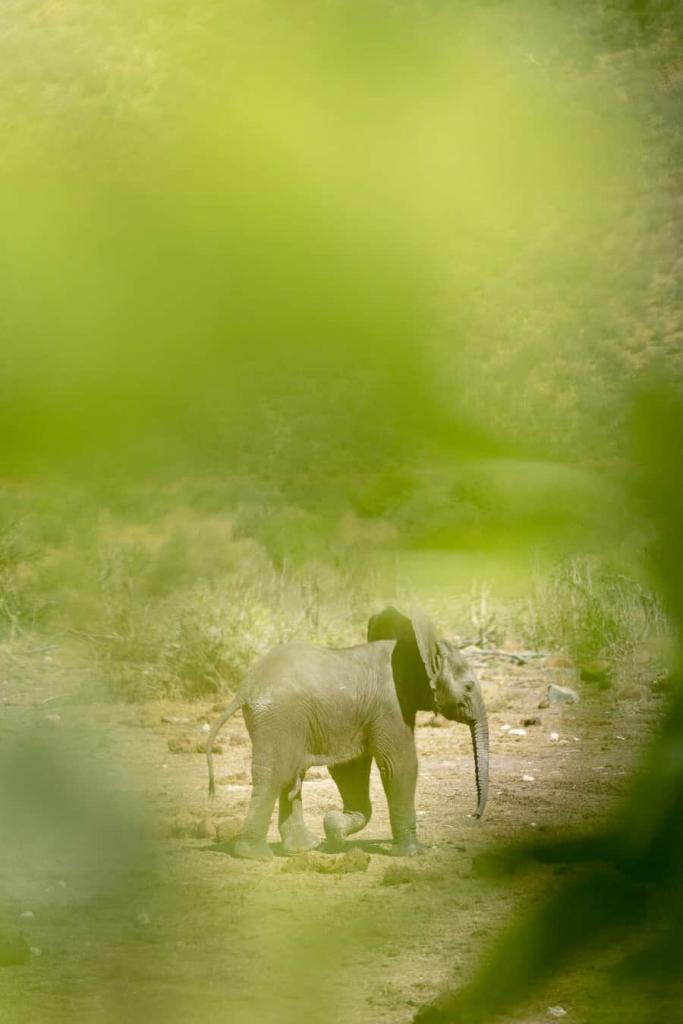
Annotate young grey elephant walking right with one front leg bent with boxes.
[207,608,488,859]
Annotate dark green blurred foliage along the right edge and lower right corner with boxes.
[415,391,683,1024]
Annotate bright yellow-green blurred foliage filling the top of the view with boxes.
[1,0,681,489]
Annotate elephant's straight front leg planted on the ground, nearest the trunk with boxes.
[377,733,425,857]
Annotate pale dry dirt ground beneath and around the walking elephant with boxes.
[0,657,658,1024]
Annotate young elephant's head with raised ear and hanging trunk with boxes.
[368,608,488,818]
